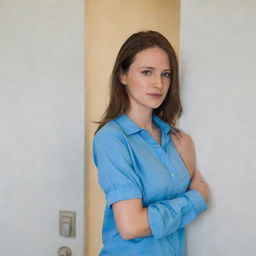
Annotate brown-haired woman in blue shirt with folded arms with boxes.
[93,31,208,256]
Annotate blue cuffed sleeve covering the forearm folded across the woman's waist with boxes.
[148,190,207,239]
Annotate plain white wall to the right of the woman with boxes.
[180,0,256,256]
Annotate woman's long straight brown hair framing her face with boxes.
[95,30,182,134]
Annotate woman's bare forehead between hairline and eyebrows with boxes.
[132,47,170,68]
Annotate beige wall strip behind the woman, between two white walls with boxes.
[85,0,180,256]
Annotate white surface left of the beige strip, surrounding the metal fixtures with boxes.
[0,0,84,256]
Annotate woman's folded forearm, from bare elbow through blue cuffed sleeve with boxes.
[129,191,206,239]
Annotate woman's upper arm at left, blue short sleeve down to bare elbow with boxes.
[93,129,147,239]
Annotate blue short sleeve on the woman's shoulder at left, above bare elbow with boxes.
[93,130,142,207]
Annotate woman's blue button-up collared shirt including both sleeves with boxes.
[93,114,207,256]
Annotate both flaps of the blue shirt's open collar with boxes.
[114,113,171,135]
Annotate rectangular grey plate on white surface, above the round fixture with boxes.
[59,211,76,237]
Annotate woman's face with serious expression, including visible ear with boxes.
[121,47,171,112]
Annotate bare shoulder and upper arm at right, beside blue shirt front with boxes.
[171,130,196,178]
